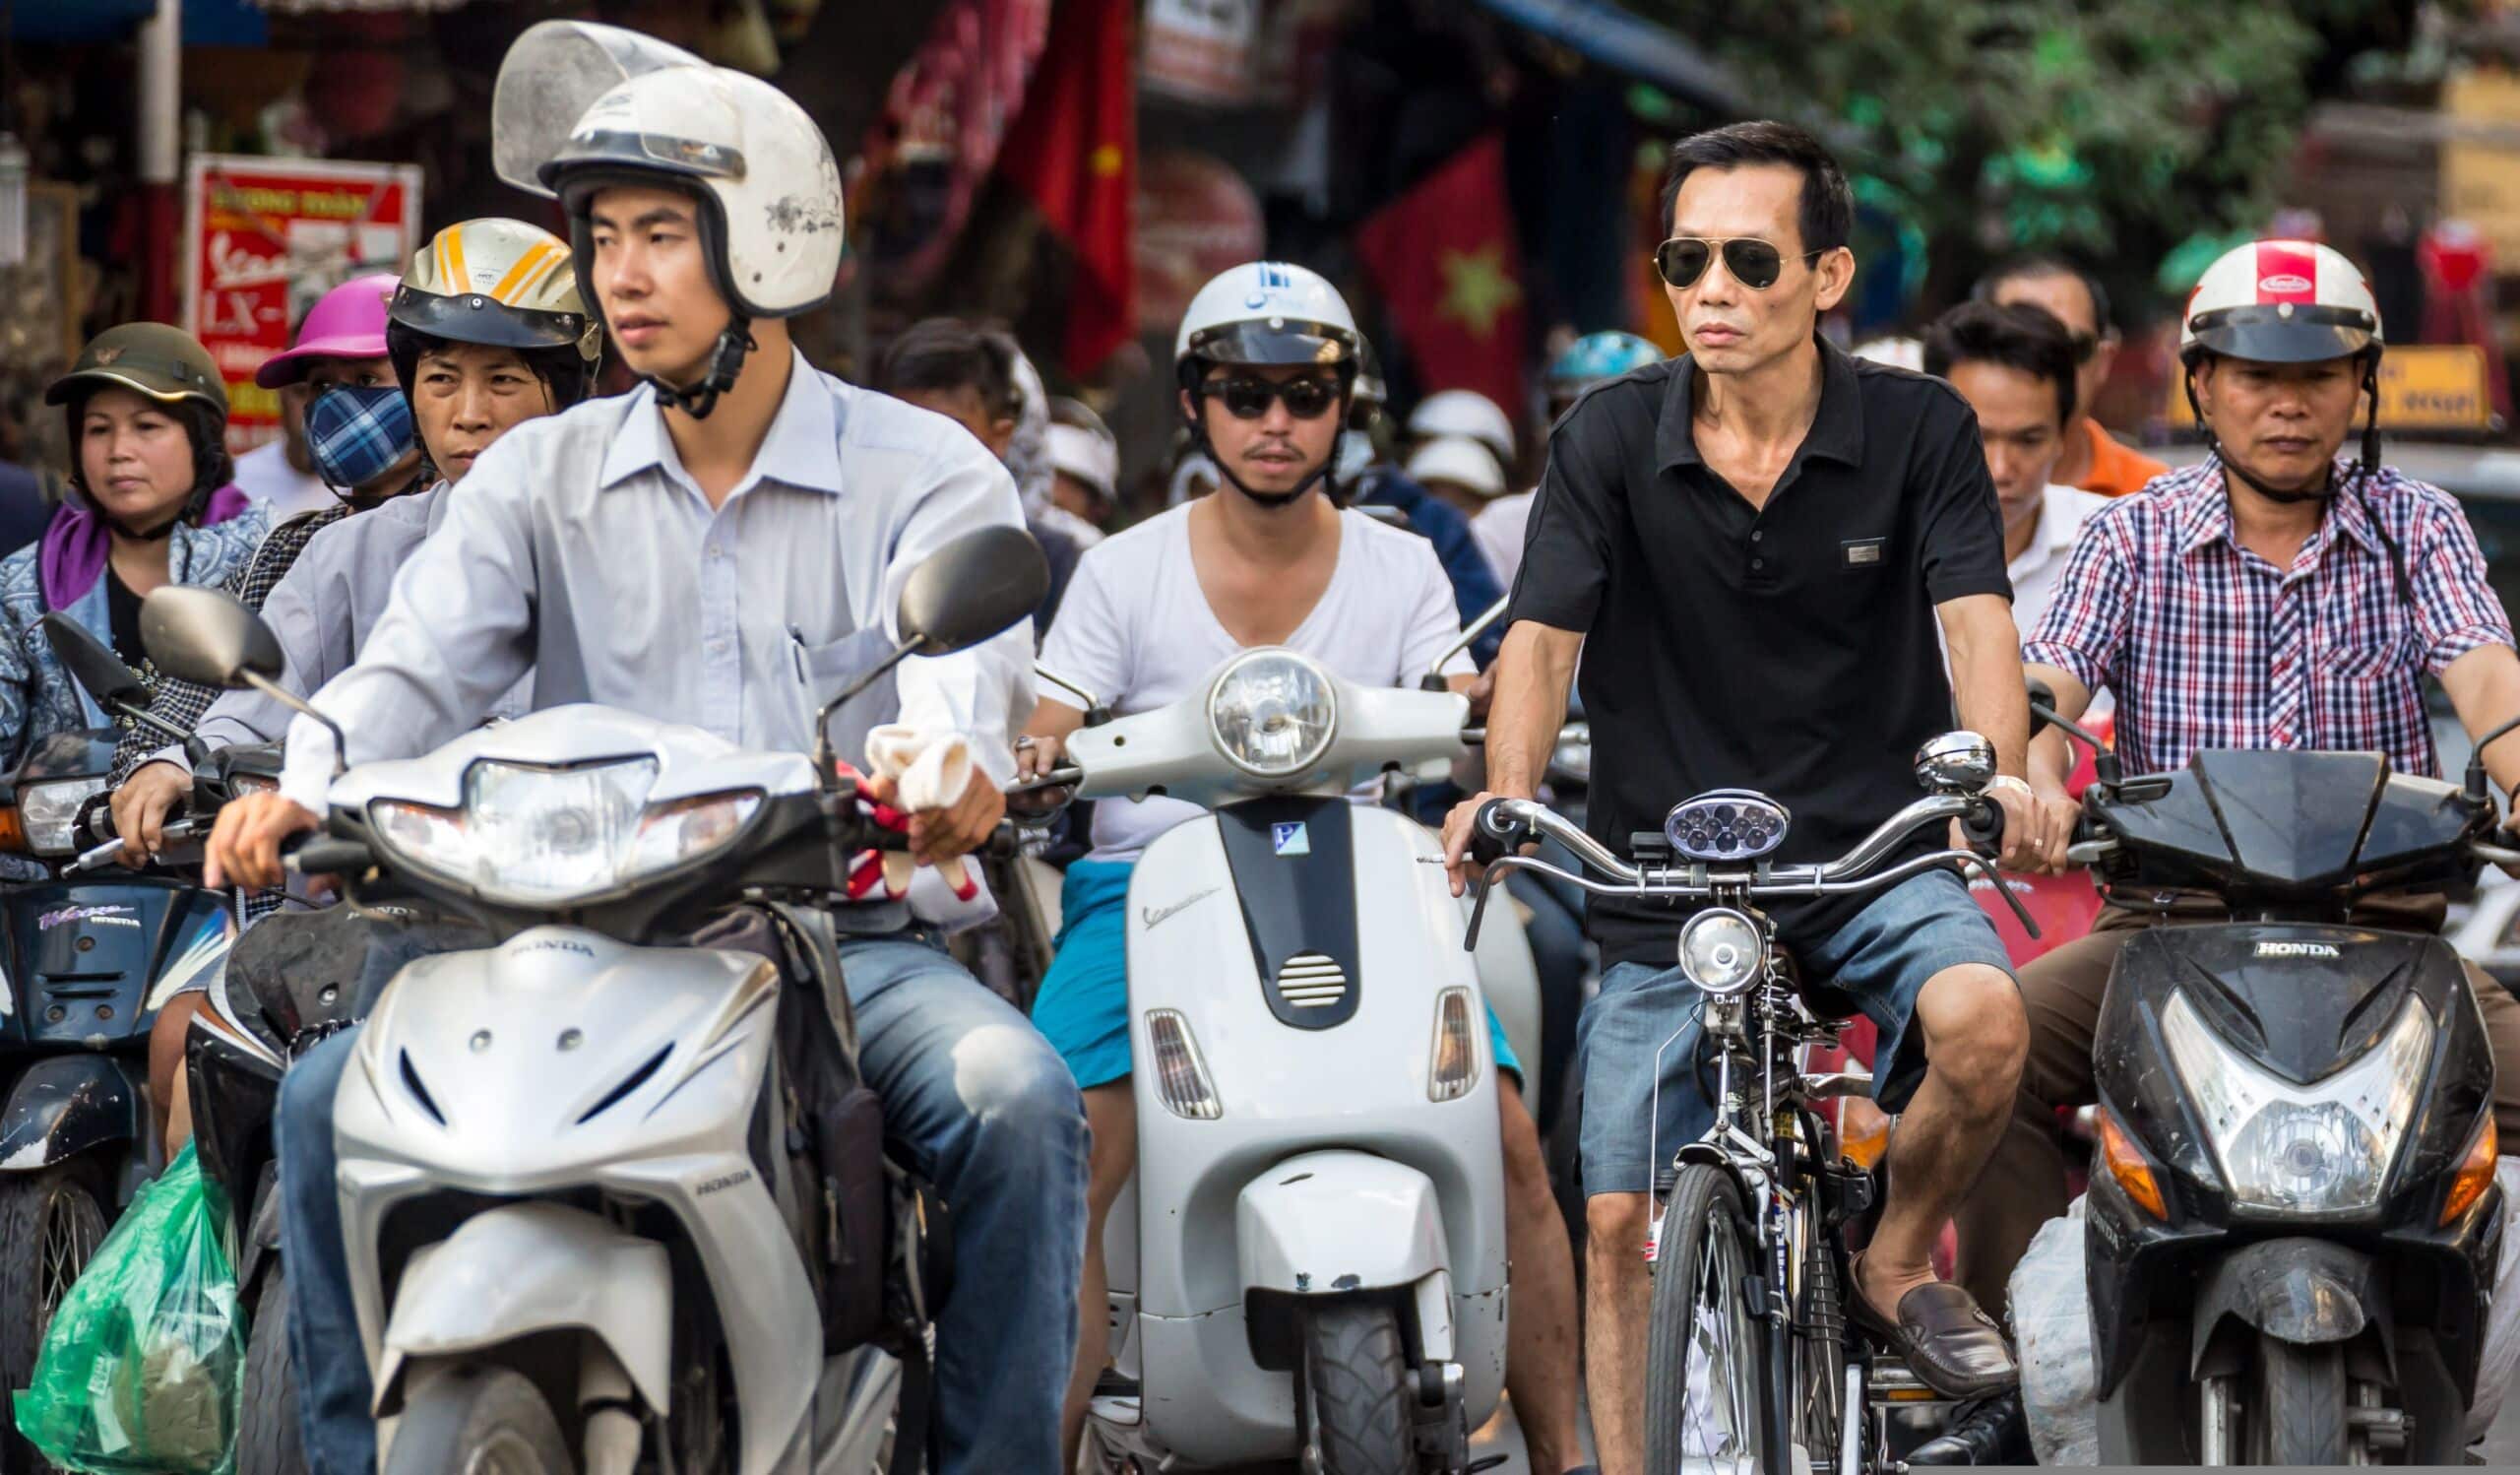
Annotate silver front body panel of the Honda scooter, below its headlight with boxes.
[333,926,824,1475]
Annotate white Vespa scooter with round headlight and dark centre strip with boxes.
[1028,637,1538,1475]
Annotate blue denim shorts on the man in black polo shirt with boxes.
[1575,869,2013,1195]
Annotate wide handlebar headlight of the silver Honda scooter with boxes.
[368,759,761,903]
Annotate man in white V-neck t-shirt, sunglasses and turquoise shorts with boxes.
[1016,262,1583,1475]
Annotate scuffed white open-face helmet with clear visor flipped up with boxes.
[491,20,842,318]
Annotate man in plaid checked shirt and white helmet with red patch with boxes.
[1958,242,2520,1451]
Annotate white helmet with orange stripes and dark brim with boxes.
[386,215,604,406]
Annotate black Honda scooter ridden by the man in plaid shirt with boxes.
[2031,698,2520,1465]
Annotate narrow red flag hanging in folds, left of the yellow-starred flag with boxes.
[998,0,1137,376]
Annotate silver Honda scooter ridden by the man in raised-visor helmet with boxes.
[141,527,1045,1475]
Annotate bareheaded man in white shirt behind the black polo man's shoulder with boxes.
[1925,302,2110,700]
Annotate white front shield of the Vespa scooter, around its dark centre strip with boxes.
[1134,800,1504,1465]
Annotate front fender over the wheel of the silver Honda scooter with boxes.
[375,1202,673,1417]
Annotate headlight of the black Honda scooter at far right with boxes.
[2162,989,2434,1215]
